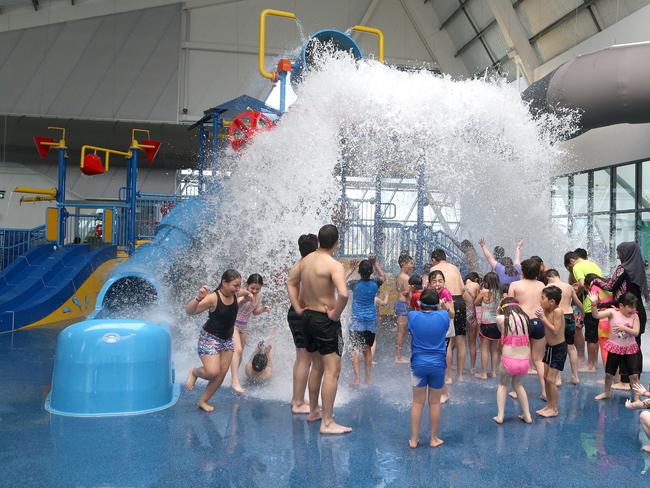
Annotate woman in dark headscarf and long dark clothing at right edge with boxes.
[593,242,648,345]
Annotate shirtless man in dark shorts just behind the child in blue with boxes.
[427,248,467,381]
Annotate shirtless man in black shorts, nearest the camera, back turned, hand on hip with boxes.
[287,224,352,434]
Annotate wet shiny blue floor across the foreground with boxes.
[0,330,650,488]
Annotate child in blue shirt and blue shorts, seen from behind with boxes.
[408,289,453,449]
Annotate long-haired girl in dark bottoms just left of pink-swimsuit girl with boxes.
[474,271,501,380]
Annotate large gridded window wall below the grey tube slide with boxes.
[552,160,650,268]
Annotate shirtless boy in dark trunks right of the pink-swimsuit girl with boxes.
[535,285,567,417]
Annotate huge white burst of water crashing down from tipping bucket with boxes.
[174,53,574,402]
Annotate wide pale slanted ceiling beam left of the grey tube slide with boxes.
[488,0,540,83]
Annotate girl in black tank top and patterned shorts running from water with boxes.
[185,269,252,412]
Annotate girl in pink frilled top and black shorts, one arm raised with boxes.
[589,293,643,401]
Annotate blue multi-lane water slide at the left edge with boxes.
[0,244,117,332]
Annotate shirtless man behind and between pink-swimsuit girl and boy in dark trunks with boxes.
[508,259,546,400]
